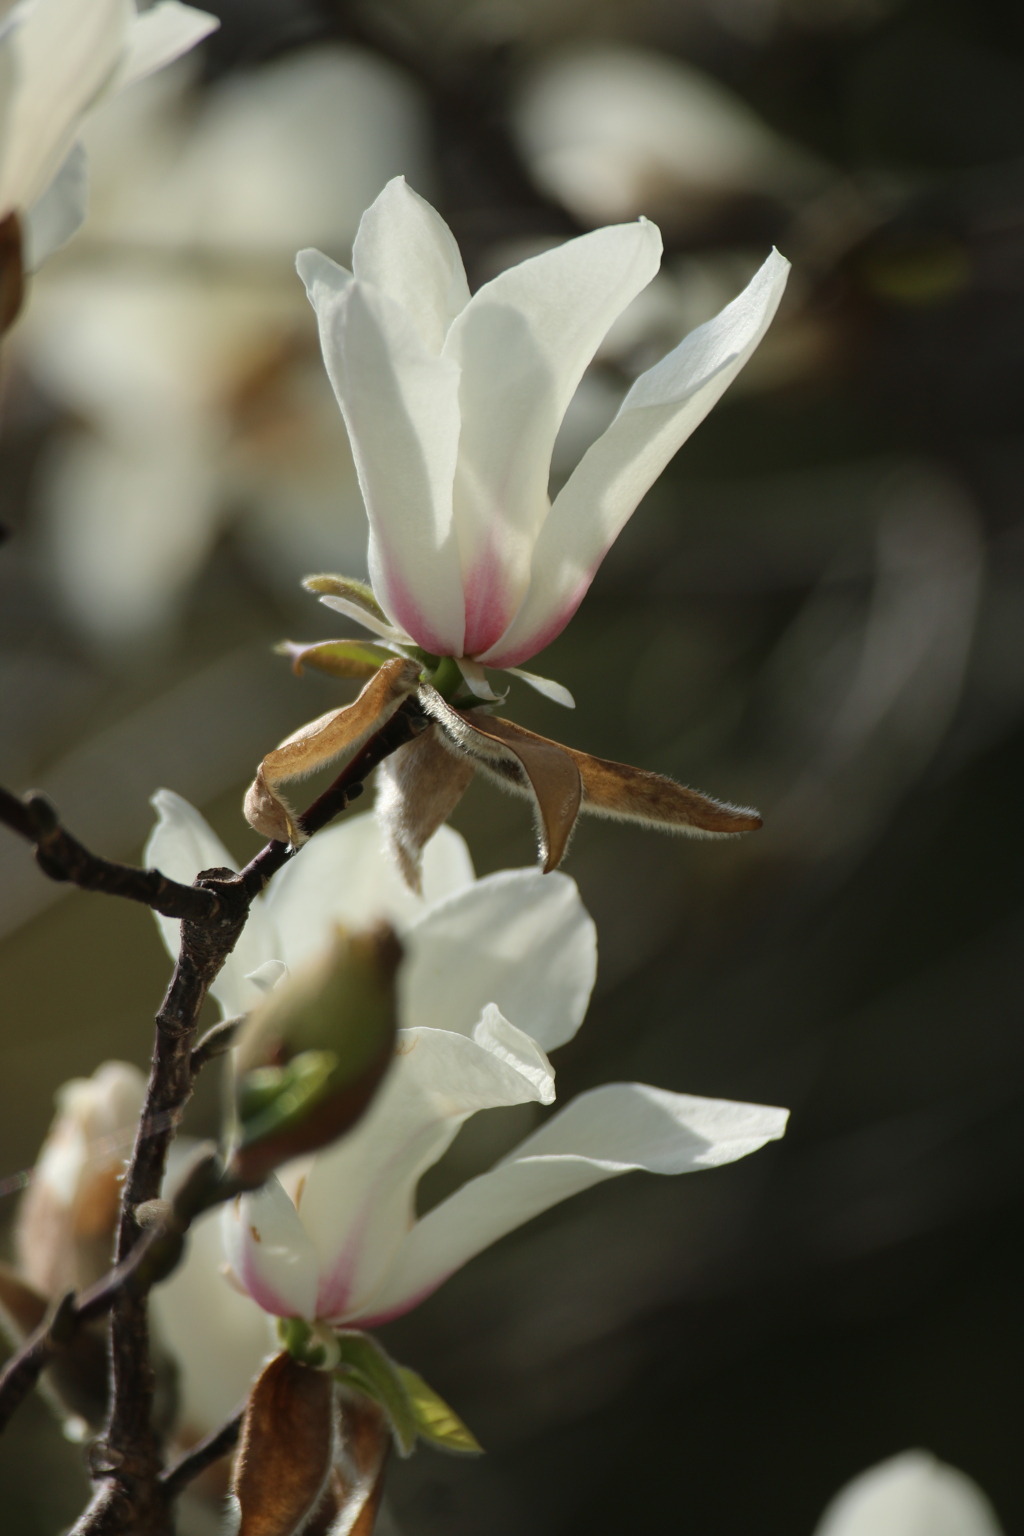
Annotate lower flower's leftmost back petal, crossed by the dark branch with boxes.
[143,790,275,1018]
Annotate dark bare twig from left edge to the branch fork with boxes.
[0,788,220,922]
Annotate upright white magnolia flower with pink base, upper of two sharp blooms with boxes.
[298,180,789,697]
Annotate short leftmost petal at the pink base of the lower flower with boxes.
[221,1174,319,1322]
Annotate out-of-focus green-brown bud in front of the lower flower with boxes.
[232,925,402,1184]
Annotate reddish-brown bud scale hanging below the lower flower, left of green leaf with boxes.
[232,1353,335,1536]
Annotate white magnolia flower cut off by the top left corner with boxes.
[0,0,220,270]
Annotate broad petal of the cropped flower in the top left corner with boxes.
[0,0,127,212]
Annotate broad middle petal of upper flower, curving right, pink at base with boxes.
[444,221,662,656]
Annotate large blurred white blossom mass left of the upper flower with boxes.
[17,46,428,645]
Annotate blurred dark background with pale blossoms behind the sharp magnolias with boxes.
[0,0,1024,1536]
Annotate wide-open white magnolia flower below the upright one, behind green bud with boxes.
[147,791,786,1419]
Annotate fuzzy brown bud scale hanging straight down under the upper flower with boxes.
[375,725,473,895]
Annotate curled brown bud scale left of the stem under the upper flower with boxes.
[246,656,419,845]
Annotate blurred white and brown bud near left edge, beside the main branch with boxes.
[14,1061,146,1296]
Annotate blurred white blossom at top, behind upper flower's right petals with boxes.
[513,45,827,229]
